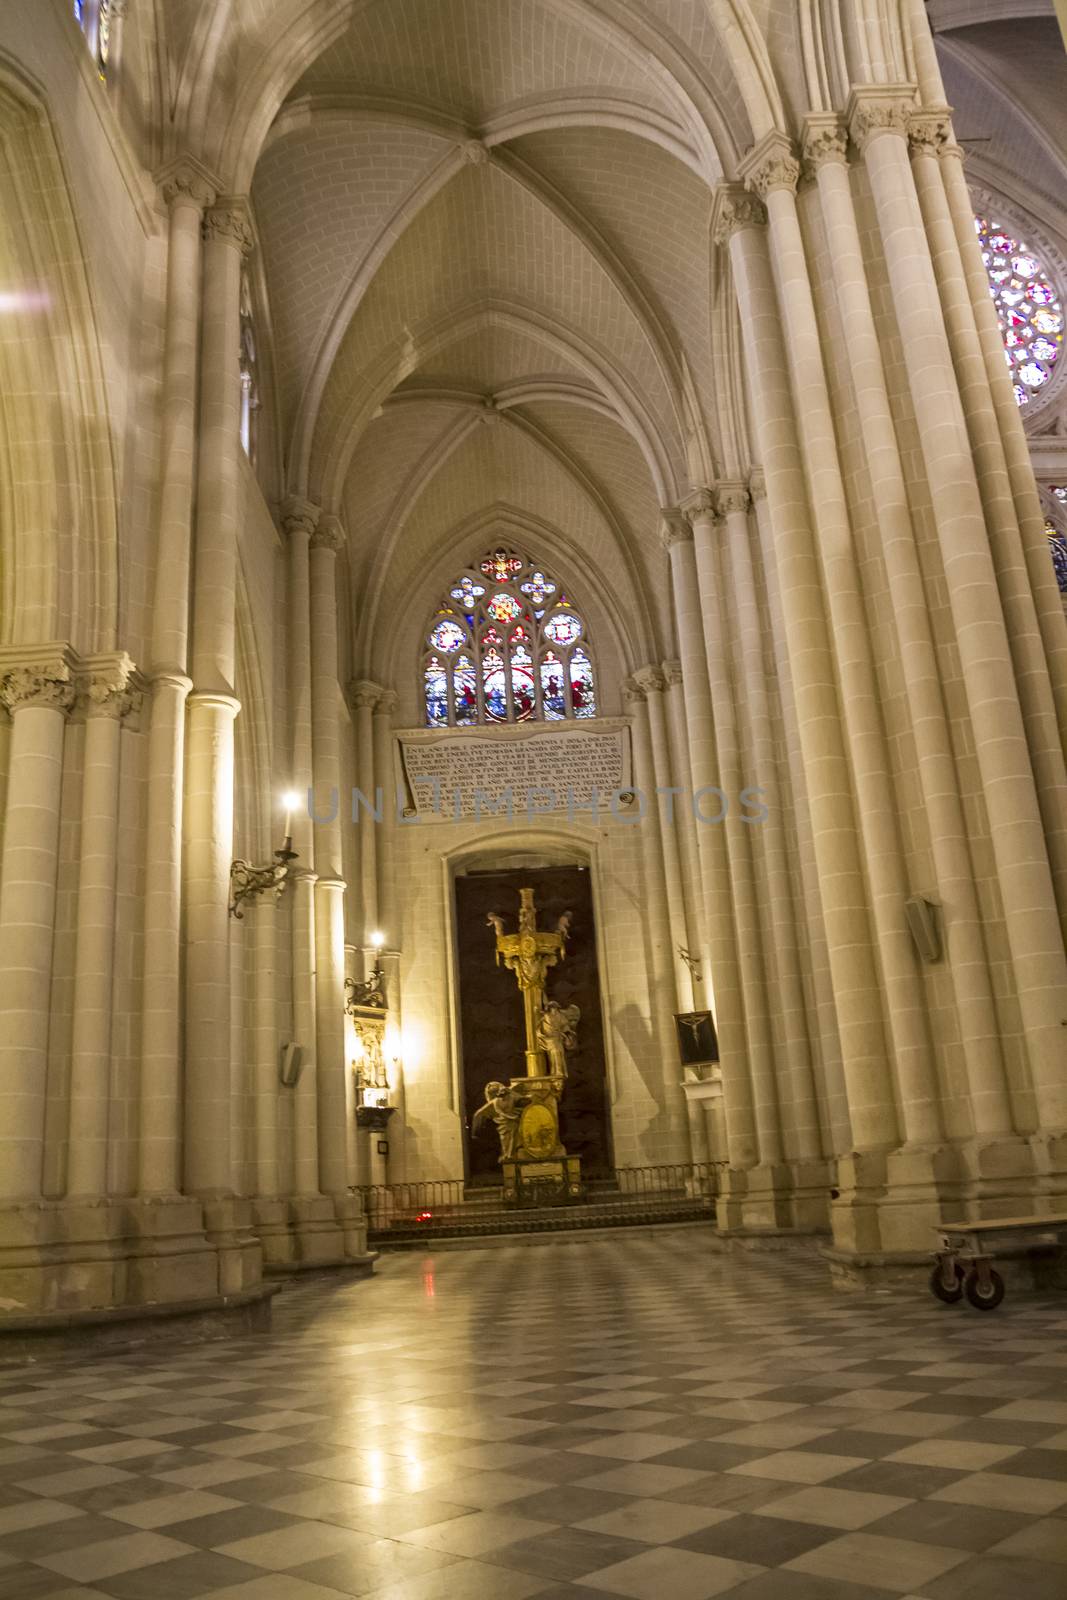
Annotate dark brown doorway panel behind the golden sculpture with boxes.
[456,867,611,1182]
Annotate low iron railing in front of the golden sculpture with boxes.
[360,1162,723,1245]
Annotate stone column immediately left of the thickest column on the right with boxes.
[805,115,1011,1136]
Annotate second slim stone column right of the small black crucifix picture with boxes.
[681,490,782,1166]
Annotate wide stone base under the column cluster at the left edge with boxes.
[0,1197,262,1328]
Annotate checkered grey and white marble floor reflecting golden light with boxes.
[0,1229,1067,1600]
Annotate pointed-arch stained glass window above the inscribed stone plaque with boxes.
[422,546,597,728]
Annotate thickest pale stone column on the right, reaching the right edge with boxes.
[849,93,1067,1133]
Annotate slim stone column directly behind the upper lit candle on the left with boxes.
[282,499,320,1195]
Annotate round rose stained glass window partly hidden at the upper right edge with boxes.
[974,214,1064,405]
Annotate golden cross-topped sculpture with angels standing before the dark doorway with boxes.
[472,888,581,1200]
